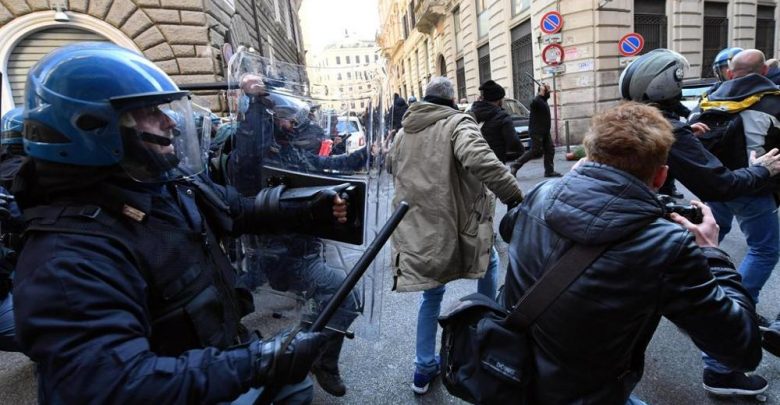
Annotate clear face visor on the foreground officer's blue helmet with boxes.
[119,97,204,183]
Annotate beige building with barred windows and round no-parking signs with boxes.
[378,0,780,144]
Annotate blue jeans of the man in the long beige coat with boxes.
[414,247,499,374]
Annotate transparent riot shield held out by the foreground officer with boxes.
[228,51,390,338]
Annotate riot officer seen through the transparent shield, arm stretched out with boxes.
[222,74,369,397]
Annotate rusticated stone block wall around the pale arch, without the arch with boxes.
[0,0,304,111]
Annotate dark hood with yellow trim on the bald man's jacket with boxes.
[701,73,780,112]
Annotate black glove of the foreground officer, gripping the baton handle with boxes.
[249,331,327,387]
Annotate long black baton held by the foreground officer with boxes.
[254,201,409,404]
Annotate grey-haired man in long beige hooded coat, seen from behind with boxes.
[388,77,523,394]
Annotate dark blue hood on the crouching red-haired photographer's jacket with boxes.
[544,162,663,245]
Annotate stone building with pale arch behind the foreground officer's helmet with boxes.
[0,0,304,113]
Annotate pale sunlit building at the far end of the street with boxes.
[306,37,379,112]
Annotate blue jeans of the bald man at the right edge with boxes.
[702,194,780,374]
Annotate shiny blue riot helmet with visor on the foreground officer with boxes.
[24,43,203,182]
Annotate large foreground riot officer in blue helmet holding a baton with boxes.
[14,44,346,403]
